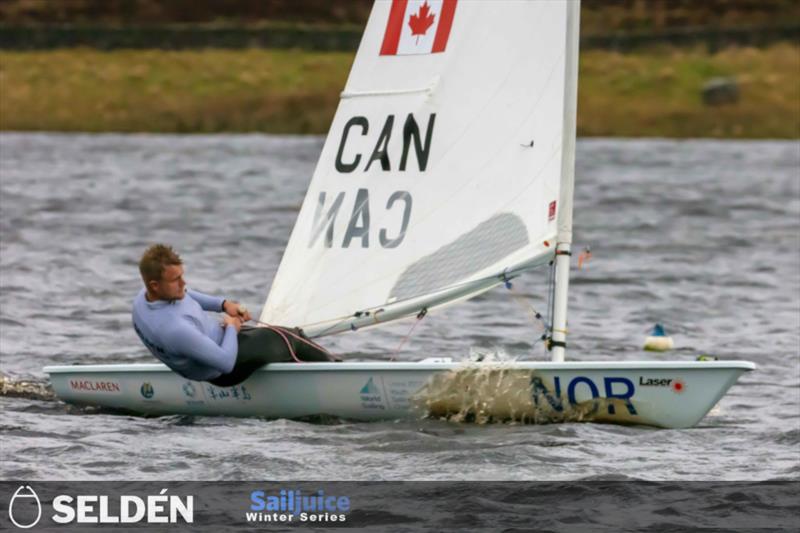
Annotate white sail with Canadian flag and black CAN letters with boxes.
[261,0,574,334]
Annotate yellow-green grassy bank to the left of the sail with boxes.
[0,50,352,133]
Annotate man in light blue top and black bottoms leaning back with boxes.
[133,244,333,387]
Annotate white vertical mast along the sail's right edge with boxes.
[550,0,581,362]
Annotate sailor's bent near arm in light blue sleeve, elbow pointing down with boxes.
[164,320,239,374]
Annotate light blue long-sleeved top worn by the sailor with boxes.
[133,289,239,381]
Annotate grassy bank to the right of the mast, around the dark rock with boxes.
[578,44,800,138]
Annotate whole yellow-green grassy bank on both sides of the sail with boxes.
[0,44,800,138]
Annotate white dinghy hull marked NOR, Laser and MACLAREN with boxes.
[44,361,755,428]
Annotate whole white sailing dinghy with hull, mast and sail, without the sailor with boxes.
[44,0,755,428]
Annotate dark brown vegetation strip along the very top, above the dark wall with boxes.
[0,0,800,34]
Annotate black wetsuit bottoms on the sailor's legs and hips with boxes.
[208,326,336,387]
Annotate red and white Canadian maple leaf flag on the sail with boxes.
[381,0,457,56]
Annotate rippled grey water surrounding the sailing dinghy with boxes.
[0,134,800,480]
